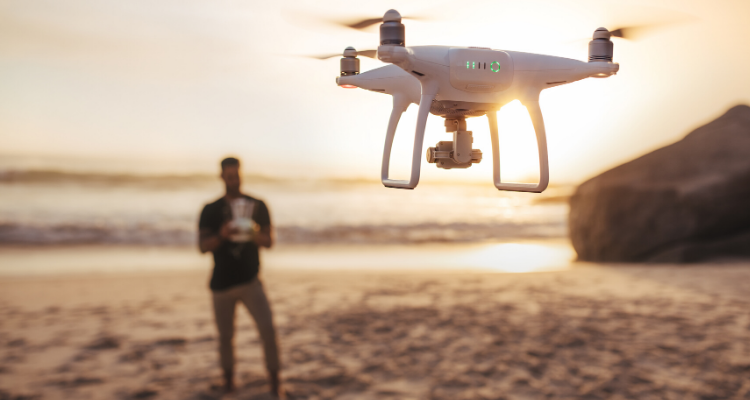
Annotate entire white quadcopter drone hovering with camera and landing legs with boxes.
[323,10,621,193]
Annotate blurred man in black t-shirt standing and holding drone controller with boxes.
[198,157,281,397]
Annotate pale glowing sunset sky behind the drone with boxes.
[0,0,750,184]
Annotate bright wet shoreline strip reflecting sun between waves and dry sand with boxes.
[0,238,575,279]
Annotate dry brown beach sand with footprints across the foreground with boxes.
[0,258,750,400]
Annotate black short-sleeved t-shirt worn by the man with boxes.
[198,195,271,291]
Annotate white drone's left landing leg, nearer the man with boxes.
[380,94,435,189]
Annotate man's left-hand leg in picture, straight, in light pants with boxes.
[213,289,237,391]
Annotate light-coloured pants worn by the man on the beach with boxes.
[212,278,279,372]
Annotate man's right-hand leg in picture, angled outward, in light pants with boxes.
[240,278,281,396]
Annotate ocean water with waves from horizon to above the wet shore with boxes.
[0,171,572,246]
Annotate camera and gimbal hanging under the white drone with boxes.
[426,117,482,169]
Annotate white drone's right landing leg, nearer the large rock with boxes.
[487,101,549,193]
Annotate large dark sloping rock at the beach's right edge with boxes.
[569,105,750,262]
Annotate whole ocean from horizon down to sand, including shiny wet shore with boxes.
[0,165,574,276]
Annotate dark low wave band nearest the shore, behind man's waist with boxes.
[0,222,567,246]
